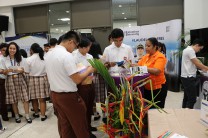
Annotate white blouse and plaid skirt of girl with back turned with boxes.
[26,53,50,99]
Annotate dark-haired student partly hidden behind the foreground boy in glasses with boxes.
[74,38,97,137]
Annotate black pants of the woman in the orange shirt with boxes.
[144,83,168,109]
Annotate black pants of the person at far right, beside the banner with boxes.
[181,77,197,109]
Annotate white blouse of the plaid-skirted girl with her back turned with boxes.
[25,53,46,76]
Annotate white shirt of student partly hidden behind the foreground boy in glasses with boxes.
[72,50,93,67]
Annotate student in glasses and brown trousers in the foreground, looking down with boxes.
[45,31,94,138]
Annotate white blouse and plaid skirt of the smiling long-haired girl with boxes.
[2,56,30,104]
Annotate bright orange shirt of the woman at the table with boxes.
[138,51,167,90]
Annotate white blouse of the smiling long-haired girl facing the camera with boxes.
[2,56,25,75]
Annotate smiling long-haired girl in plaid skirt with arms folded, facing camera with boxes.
[2,42,32,123]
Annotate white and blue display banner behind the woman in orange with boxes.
[121,19,182,91]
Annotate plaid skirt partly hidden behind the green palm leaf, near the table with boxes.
[93,73,106,103]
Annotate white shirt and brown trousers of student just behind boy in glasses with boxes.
[73,50,95,131]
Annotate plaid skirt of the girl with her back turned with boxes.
[28,75,50,99]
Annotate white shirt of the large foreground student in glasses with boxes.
[45,45,77,92]
